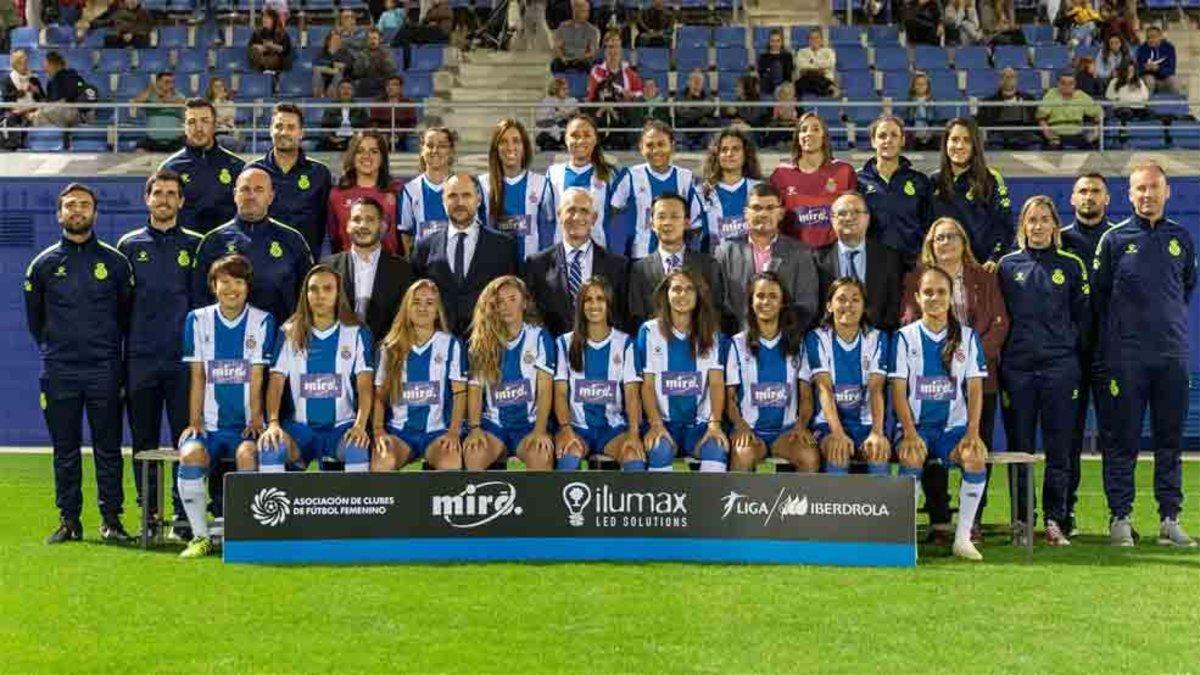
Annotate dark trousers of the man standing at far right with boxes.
[1104,354,1188,518]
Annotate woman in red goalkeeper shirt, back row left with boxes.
[325,131,407,255]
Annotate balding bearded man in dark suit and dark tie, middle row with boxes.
[413,173,517,338]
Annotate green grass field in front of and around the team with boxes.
[0,455,1200,673]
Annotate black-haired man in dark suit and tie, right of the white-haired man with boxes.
[629,192,733,330]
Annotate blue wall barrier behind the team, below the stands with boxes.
[0,177,1200,446]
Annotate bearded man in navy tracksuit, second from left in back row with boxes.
[250,103,334,256]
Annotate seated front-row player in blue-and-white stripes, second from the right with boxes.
[805,277,892,474]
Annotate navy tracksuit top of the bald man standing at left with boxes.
[192,216,312,325]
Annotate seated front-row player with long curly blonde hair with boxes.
[463,276,556,471]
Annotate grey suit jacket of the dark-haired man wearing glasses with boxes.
[716,234,820,333]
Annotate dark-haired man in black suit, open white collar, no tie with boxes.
[322,197,413,345]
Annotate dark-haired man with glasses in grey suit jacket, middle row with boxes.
[716,183,821,330]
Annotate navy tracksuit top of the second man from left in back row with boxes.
[247,150,334,257]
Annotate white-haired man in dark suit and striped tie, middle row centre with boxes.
[526,187,630,335]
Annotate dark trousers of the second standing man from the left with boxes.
[126,359,187,515]
